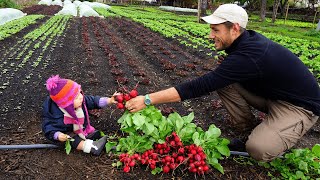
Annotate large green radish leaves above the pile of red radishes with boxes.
[106,106,230,174]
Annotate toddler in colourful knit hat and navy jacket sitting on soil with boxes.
[42,75,116,155]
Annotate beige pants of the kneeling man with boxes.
[217,84,319,161]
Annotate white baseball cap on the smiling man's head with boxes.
[201,4,248,28]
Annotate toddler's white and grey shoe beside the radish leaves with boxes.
[83,136,107,156]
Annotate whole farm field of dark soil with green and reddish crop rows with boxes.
[0,6,320,179]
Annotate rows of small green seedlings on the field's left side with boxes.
[0,16,70,93]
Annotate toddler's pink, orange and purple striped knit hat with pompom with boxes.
[46,75,81,119]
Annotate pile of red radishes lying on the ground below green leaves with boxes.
[119,132,209,175]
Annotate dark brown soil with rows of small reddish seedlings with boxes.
[0,5,320,179]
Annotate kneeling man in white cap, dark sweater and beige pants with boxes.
[126,4,320,161]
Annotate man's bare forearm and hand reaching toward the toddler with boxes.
[126,87,181,112]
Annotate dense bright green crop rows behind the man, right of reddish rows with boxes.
[96,7,320,78]
